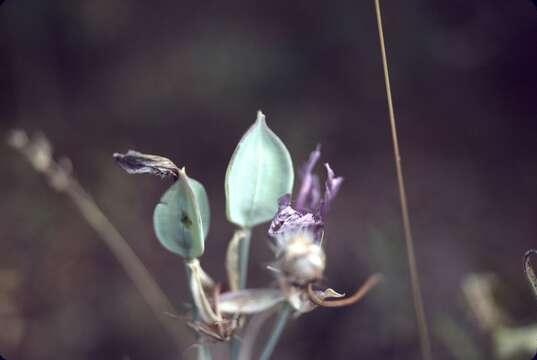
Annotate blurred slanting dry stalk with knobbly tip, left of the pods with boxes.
[8,130,183,346]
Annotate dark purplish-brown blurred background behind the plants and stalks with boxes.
[0,0,537,360]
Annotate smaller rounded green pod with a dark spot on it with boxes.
[153,169,210,258]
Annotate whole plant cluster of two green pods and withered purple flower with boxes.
[114,112,380,354]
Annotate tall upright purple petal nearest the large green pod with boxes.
[296,144,321,211]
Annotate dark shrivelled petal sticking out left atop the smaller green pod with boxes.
[114,150,179,180]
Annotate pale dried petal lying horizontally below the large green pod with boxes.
[218,289,284,314]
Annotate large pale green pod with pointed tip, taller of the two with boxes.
[225,111,294,228]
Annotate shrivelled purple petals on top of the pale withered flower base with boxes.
[268,145,343,250]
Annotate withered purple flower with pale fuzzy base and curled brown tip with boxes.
[268,146,380,314]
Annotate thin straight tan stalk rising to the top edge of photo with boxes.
[375,0,432,360]
